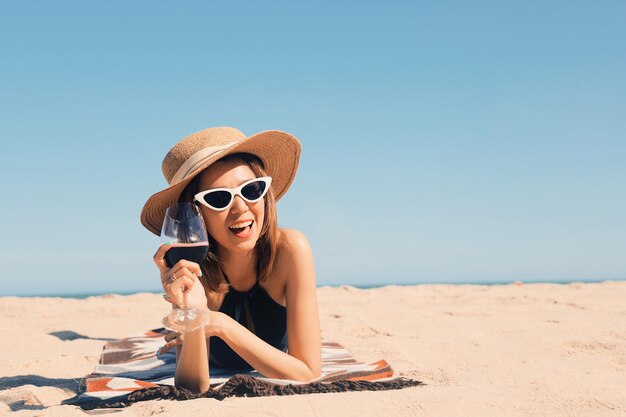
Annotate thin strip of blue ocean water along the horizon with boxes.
[0,278,626,299]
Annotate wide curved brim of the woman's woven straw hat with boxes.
[141,130,301,236]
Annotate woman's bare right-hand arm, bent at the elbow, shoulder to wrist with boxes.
[219,230,322,381]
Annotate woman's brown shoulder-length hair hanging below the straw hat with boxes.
[178,153,278,292]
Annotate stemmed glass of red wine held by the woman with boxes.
[161,203,209,332]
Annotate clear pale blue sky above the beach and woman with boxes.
[0,1,626,295]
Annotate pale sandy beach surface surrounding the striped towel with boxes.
[0,281,626,417]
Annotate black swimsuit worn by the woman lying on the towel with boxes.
[209,278,287,371]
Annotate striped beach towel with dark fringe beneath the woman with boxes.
[63,328,422,410]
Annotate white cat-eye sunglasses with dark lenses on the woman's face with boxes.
[193,177,272,211]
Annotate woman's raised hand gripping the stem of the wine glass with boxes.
[153,240,207,309]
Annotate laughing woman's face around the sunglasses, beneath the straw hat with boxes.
[198,160,265,254]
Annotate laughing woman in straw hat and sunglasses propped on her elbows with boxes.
[141,127,321,392]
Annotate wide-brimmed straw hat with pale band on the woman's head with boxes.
[141,127,300,236]
